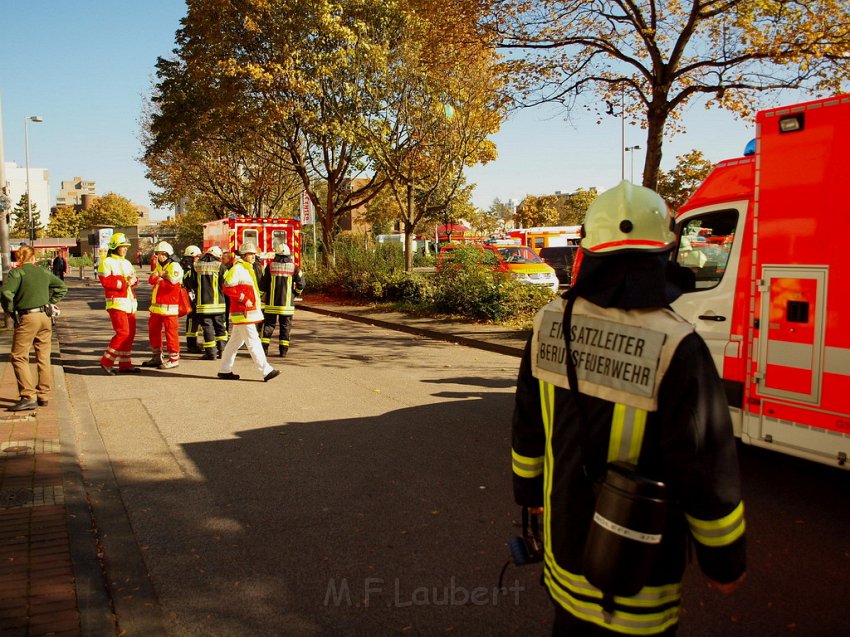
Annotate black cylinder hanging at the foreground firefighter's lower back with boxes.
[583,462,667,597]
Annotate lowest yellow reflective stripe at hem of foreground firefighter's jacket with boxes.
[543,569,679,635]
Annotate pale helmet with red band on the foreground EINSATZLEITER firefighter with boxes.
[581,181,676,255]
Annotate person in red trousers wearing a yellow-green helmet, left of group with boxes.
[97,232,142,375]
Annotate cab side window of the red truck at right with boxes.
[674,210,738,290]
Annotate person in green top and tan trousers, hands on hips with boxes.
[0,245,68,411]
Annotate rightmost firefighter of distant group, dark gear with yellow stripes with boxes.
[260,241,304,356]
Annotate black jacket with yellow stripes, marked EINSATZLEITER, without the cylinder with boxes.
[512,298,745,635]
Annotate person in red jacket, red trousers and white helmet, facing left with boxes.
[142,241,183,369]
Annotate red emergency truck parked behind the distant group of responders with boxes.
[203,217,301,265]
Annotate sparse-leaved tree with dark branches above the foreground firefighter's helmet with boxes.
[489,0,850,188]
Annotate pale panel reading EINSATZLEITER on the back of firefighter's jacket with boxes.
[534,311,666,397]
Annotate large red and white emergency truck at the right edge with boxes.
[674,95,850,468]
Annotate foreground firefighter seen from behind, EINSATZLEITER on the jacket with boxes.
[512,181,745,636]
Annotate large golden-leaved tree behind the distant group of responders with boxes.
[144,0,499,266]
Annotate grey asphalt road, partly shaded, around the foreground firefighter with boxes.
[59,283,850,637]
